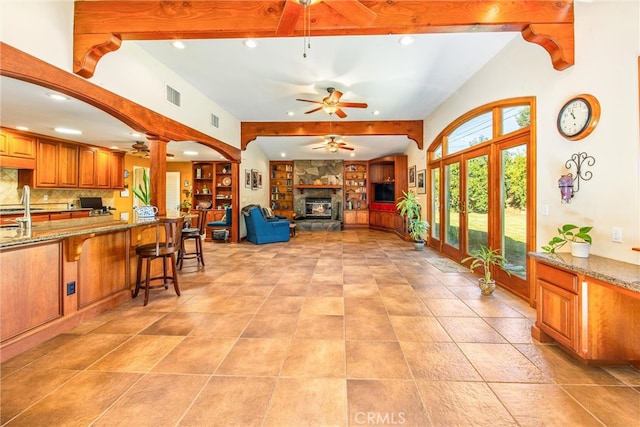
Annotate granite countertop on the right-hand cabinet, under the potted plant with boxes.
[529,252,640,293]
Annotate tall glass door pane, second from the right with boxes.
[465,154,489,254]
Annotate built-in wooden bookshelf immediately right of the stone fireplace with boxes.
[343,161,369,227]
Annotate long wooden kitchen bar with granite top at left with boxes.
[0,215,188,361]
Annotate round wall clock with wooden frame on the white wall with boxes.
[557,94,600,141]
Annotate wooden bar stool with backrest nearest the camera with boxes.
[132,217,184,306]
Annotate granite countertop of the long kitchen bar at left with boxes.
[0,215,180,248]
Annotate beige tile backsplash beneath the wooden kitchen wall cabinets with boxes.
[0,168,114,209]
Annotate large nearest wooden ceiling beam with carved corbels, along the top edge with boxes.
[73,0,574,78]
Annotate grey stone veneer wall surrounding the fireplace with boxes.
[293,160,344,220]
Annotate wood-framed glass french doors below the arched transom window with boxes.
[429,133,530,298]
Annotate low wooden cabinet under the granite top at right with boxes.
[531,255,640,367]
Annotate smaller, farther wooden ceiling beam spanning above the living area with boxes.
[240,120,423,151]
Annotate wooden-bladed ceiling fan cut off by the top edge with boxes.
[276,0,377,36]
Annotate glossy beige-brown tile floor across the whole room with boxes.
[0,230,640,426]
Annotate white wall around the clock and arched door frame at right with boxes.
[420,1,640,264]
